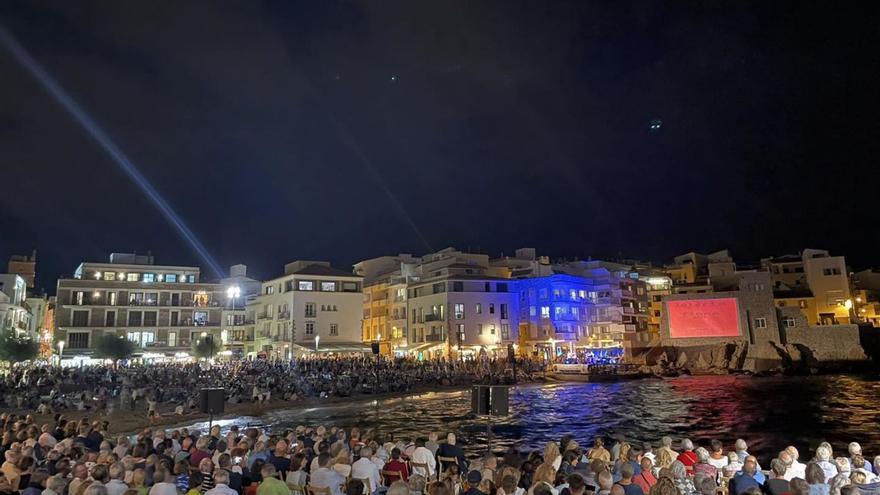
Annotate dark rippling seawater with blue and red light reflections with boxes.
[186,376,880,462]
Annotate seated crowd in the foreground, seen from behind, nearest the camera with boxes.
[0,414,880,495]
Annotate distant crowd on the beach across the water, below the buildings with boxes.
[0,357,543,414]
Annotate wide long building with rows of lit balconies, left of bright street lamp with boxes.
[55,253,226,359]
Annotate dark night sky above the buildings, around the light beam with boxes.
[0,0,880,291]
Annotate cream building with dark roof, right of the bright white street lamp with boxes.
[247,261,362,359]
